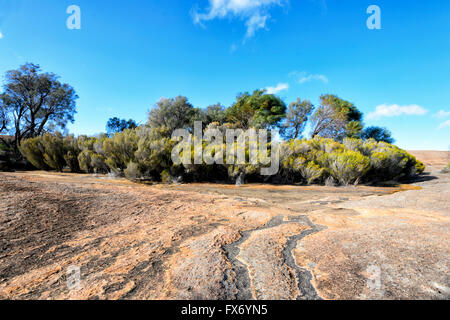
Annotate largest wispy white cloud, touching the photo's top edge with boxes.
[192,0,287,39]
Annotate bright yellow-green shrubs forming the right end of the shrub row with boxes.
[281,137,425,185]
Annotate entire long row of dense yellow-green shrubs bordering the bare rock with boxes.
[20,126,424,185]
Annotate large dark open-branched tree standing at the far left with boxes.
[0,63,78,150]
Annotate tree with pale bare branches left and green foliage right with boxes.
[311,94,363,141]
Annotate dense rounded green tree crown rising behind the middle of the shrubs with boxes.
[227,90,286,129]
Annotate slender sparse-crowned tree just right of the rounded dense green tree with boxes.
[283,98,314,140]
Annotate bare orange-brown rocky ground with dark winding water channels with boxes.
[0,155,450,299]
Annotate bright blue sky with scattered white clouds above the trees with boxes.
[0,0,450,150]
